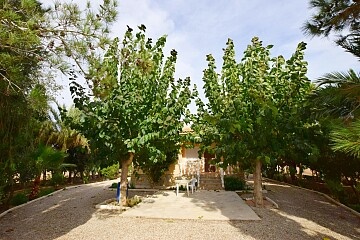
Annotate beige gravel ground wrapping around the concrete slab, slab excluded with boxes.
[0,179,360,240]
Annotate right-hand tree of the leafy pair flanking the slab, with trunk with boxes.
[194,37,311,206]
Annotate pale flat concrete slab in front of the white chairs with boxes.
[121,190,261,220]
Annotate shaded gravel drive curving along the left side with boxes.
[0,181,120,239]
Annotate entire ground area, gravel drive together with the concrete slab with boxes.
[0,181,360,240]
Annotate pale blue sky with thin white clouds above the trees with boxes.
[54,0,359,105]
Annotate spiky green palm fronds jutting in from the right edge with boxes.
[314,70,360,157]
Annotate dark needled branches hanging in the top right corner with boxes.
[303,0,360,58]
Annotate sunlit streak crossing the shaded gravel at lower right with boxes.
[272,209,351,240]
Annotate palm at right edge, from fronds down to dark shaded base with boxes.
[315,70,360,199]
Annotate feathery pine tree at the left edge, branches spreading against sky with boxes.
[0,0,116,204]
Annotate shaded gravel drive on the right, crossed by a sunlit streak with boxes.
[231,182,360,240]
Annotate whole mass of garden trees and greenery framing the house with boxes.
[0,0,360,214]
